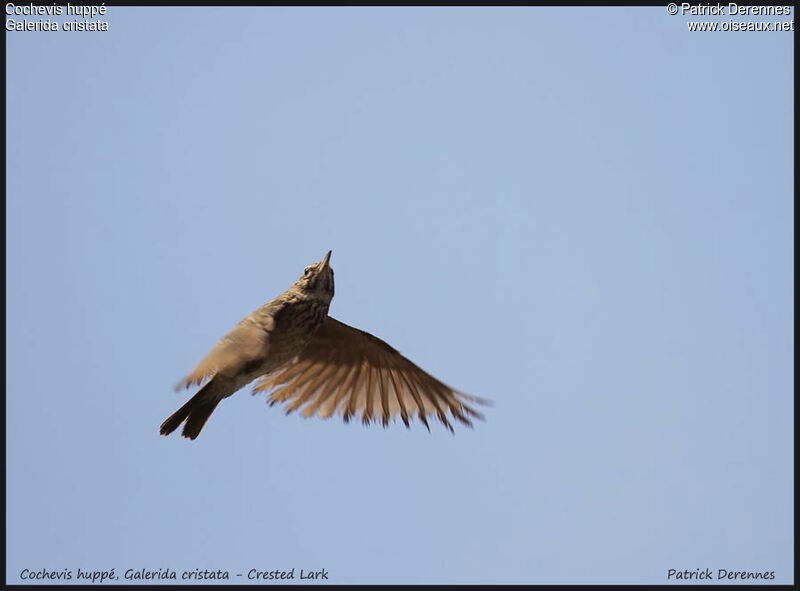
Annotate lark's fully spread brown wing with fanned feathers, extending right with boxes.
[253,316,489,431]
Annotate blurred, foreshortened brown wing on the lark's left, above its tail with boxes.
[175,314,269,390]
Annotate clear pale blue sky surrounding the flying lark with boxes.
[6,7,794,583]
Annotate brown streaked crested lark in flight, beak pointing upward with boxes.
[160,250,491,440]
